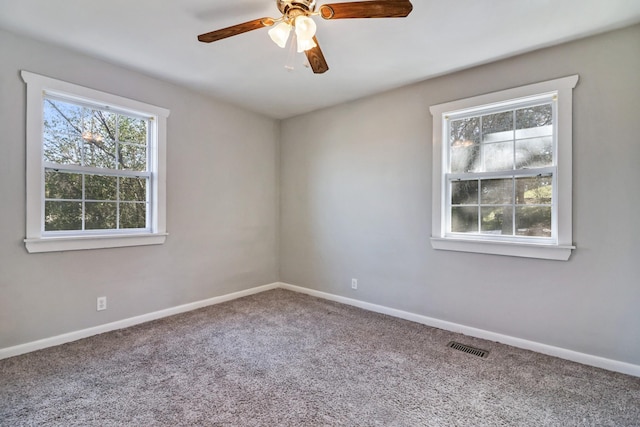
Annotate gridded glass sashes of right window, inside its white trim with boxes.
[443,98,557,242]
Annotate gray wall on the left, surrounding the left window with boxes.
[0,32,279,348]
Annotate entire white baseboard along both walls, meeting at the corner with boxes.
[0,282,640,377]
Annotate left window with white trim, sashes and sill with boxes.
[22,71,169,252]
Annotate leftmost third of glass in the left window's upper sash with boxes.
[43,99,83,165]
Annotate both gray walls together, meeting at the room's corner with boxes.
[0,26,640,364]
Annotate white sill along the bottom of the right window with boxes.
[431,237,576,261]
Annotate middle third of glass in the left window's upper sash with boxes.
[82,109,117,169]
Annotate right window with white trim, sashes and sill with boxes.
[431,75,578,260]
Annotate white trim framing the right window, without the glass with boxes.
[429,75,579,261]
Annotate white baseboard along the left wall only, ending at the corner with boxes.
[0,283,280,360]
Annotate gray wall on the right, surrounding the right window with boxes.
[280,26,640,364]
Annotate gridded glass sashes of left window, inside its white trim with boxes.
[43,94,152,234]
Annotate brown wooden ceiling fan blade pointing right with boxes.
[320,0,413,19]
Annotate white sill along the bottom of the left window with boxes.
[24,233,167,253]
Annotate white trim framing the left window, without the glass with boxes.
[21,70,170,253]
